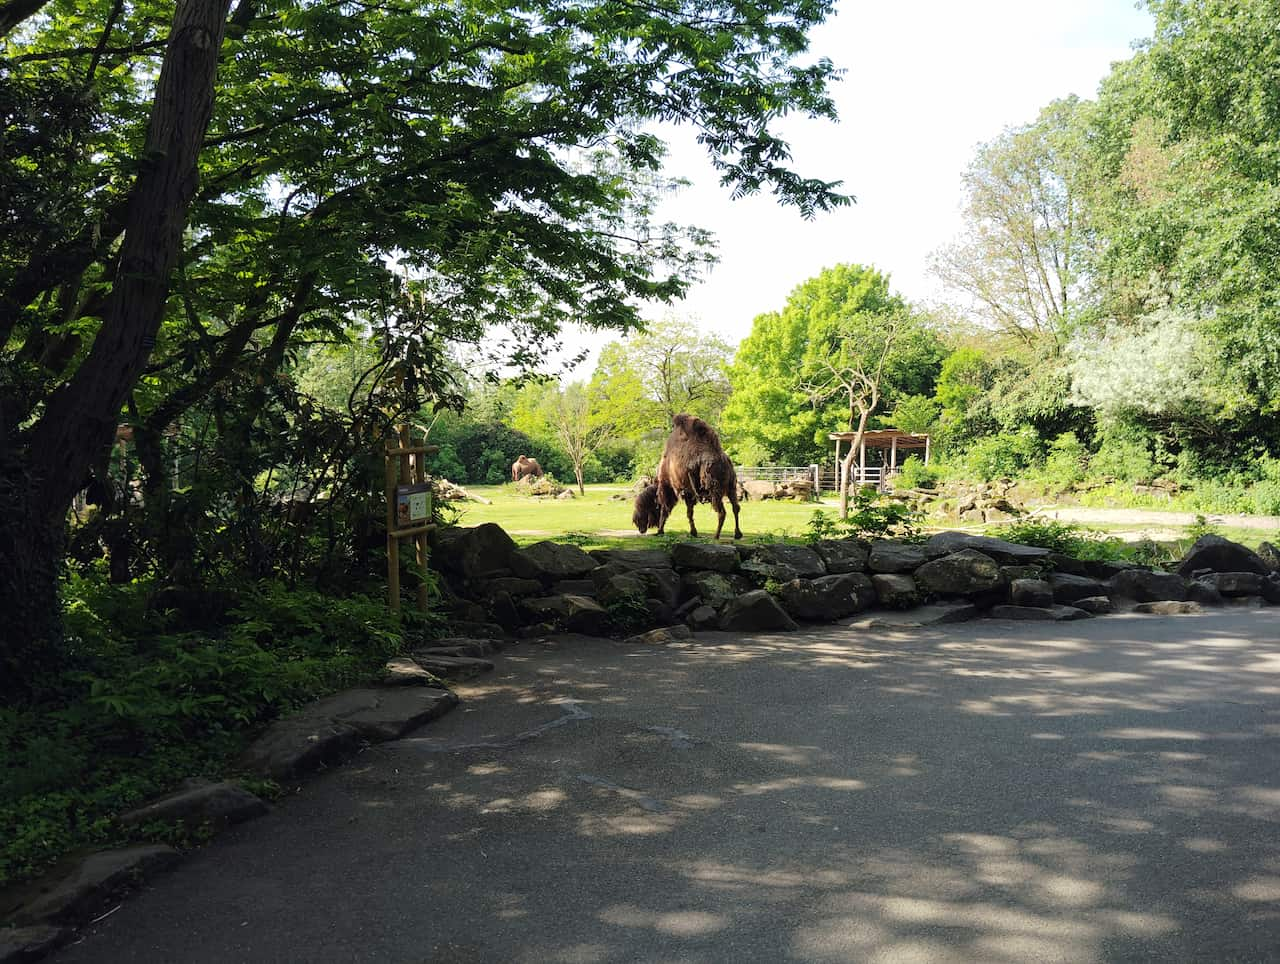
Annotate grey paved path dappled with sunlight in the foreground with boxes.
[58,611,1280,964]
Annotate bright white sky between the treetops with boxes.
[567,0,1151,378]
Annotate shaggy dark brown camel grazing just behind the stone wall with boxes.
[635,415,742,539]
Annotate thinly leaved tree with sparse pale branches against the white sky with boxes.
[933,97,1084,349]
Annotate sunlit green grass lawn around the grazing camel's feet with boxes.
[456,484,836,548]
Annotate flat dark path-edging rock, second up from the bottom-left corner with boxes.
[14,844,179,926]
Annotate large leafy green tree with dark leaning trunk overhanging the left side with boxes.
[0,0,847,693]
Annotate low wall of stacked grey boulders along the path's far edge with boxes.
[431,524,1280,635]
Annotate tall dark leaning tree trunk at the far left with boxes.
[0,0,230,695]
